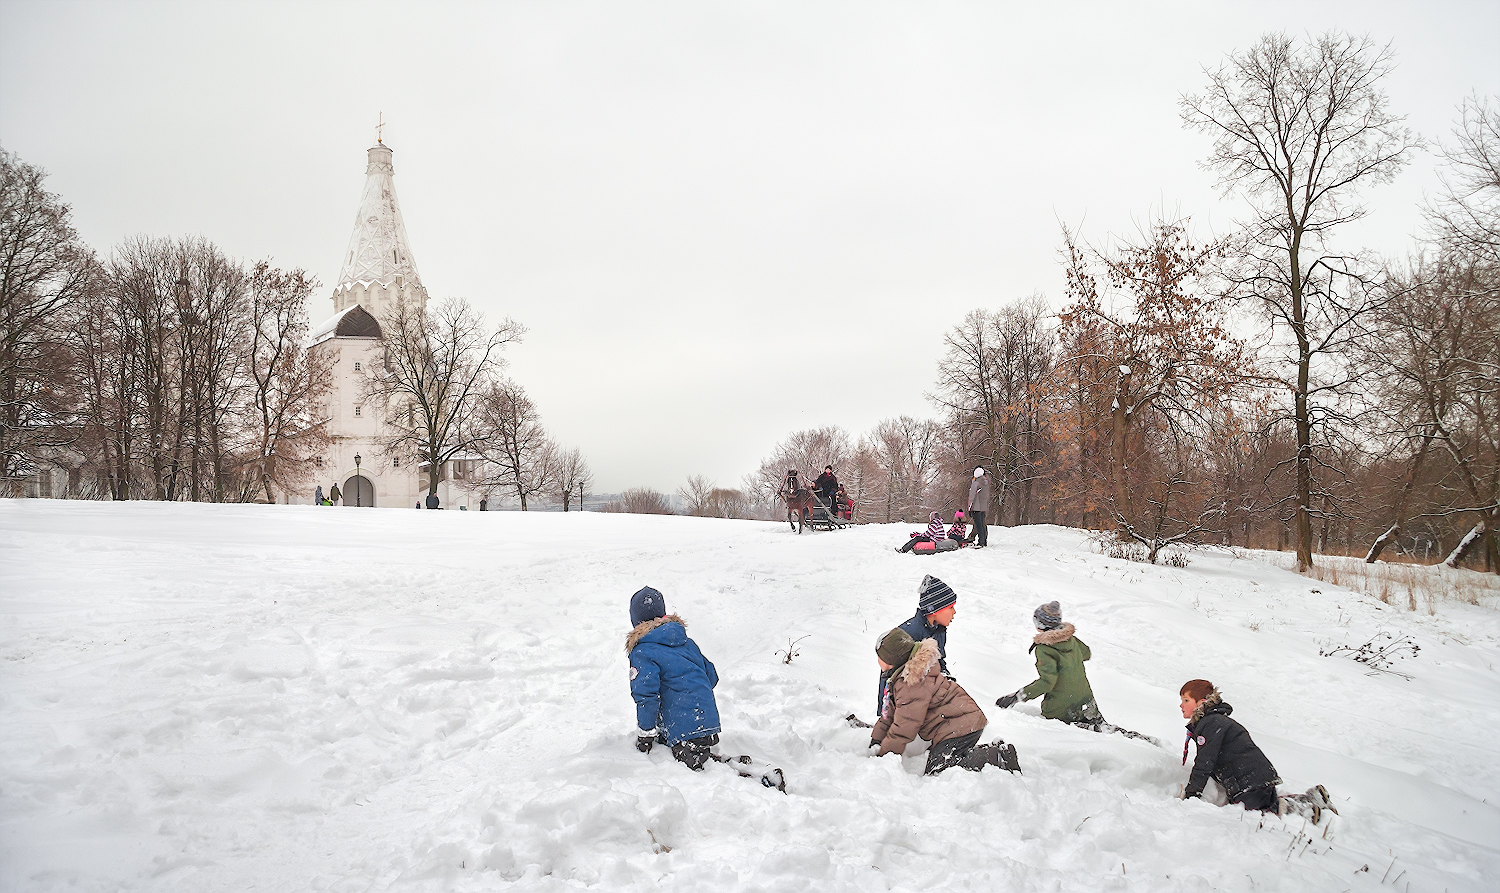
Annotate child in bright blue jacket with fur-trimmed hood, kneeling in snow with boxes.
[626,587,720,771]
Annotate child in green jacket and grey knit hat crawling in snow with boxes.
[995,602,1160,744]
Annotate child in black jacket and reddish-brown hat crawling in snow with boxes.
[1179,678,1338,824]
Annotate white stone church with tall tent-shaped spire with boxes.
[307,141,482,512]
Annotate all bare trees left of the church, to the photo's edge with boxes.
[0,143,329,501]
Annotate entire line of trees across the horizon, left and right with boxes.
[0,33,1500,572]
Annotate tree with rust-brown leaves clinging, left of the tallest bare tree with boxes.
[1061,221,1251,563]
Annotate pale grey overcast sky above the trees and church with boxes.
[0,0,1500,492]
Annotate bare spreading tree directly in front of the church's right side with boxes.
[365,297,525,494]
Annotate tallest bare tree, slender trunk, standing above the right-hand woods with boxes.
[1182,33,1421,569]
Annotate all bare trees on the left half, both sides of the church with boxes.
[0,150,591,510]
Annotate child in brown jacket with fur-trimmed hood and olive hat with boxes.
[870,627,1022,774]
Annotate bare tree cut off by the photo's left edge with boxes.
[0,149,93,492]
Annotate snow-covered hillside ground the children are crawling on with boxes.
[0,500,1500,893]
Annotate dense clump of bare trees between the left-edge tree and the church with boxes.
[69,237,330,501]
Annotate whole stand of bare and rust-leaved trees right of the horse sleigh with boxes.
[732,35,1500,570]
